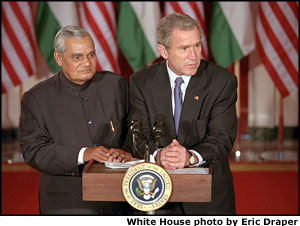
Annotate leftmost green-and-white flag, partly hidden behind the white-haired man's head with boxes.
[35,2,78,72]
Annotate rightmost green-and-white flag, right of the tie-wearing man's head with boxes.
[209,2,255,67]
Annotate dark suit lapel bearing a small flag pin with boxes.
[178,61,207,144]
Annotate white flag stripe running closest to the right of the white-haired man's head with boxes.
[79,7,113,71]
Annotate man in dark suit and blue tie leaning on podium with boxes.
[126,13,237,215]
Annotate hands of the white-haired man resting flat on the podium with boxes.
[83,146,132,162]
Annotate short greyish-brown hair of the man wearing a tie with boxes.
[156,13,201,49]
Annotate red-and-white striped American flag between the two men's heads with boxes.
[79,2,120,73]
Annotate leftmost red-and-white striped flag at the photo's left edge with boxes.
[1,2,37,93]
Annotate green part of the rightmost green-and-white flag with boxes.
[209,2,243,67]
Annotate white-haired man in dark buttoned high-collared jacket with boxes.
[19,25,132,215]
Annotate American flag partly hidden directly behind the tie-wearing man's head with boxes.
[164,2,208,59]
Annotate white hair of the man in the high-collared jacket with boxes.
[53,25,94,56]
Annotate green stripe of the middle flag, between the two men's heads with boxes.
[117,2,156,71]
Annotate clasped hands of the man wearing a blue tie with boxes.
[156,139,189,170]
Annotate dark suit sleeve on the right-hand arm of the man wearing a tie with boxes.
[188,73,237,163]
